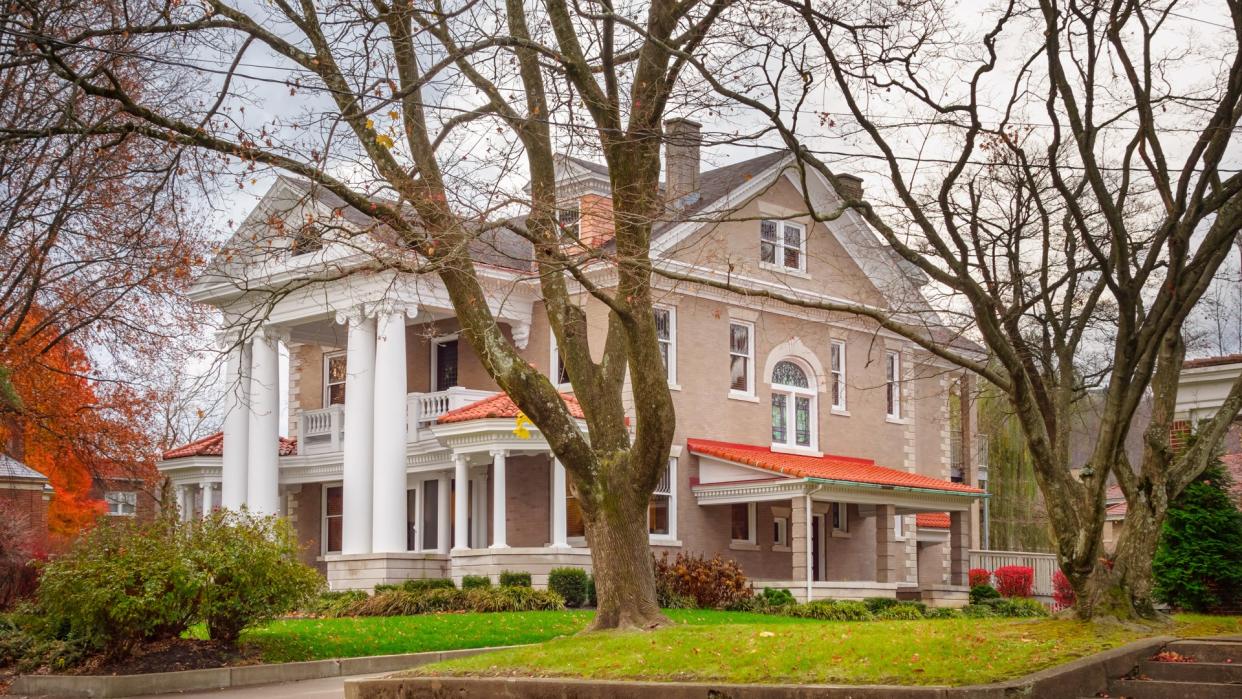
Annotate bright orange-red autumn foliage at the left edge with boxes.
[0,315,155,543]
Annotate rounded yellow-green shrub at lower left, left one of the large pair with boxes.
[37,516,198,657]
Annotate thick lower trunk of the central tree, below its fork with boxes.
[584,479,669,631]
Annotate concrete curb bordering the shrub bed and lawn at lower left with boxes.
[9,646,517,697]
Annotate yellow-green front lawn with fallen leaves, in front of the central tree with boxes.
[410,612,1242,685]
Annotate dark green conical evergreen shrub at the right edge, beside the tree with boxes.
[1151,458,1242,612]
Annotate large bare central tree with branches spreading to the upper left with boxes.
[6,0,729,628]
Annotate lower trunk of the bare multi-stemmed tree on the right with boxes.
[1074,497,1165,621]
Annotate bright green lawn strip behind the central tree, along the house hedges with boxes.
[216,610,800,663]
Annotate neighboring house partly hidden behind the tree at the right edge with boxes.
[1103,354,1242,551]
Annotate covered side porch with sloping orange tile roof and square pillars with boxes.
[688,440,984,606]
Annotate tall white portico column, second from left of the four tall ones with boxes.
[246,328,281,514]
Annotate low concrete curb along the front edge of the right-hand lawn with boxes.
[345,636,1176,699]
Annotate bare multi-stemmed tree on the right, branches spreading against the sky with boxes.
[650,0,1242,617]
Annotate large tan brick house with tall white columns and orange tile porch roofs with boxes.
[160,120,984,603]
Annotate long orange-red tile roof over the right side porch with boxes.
[687,440,982,494]
